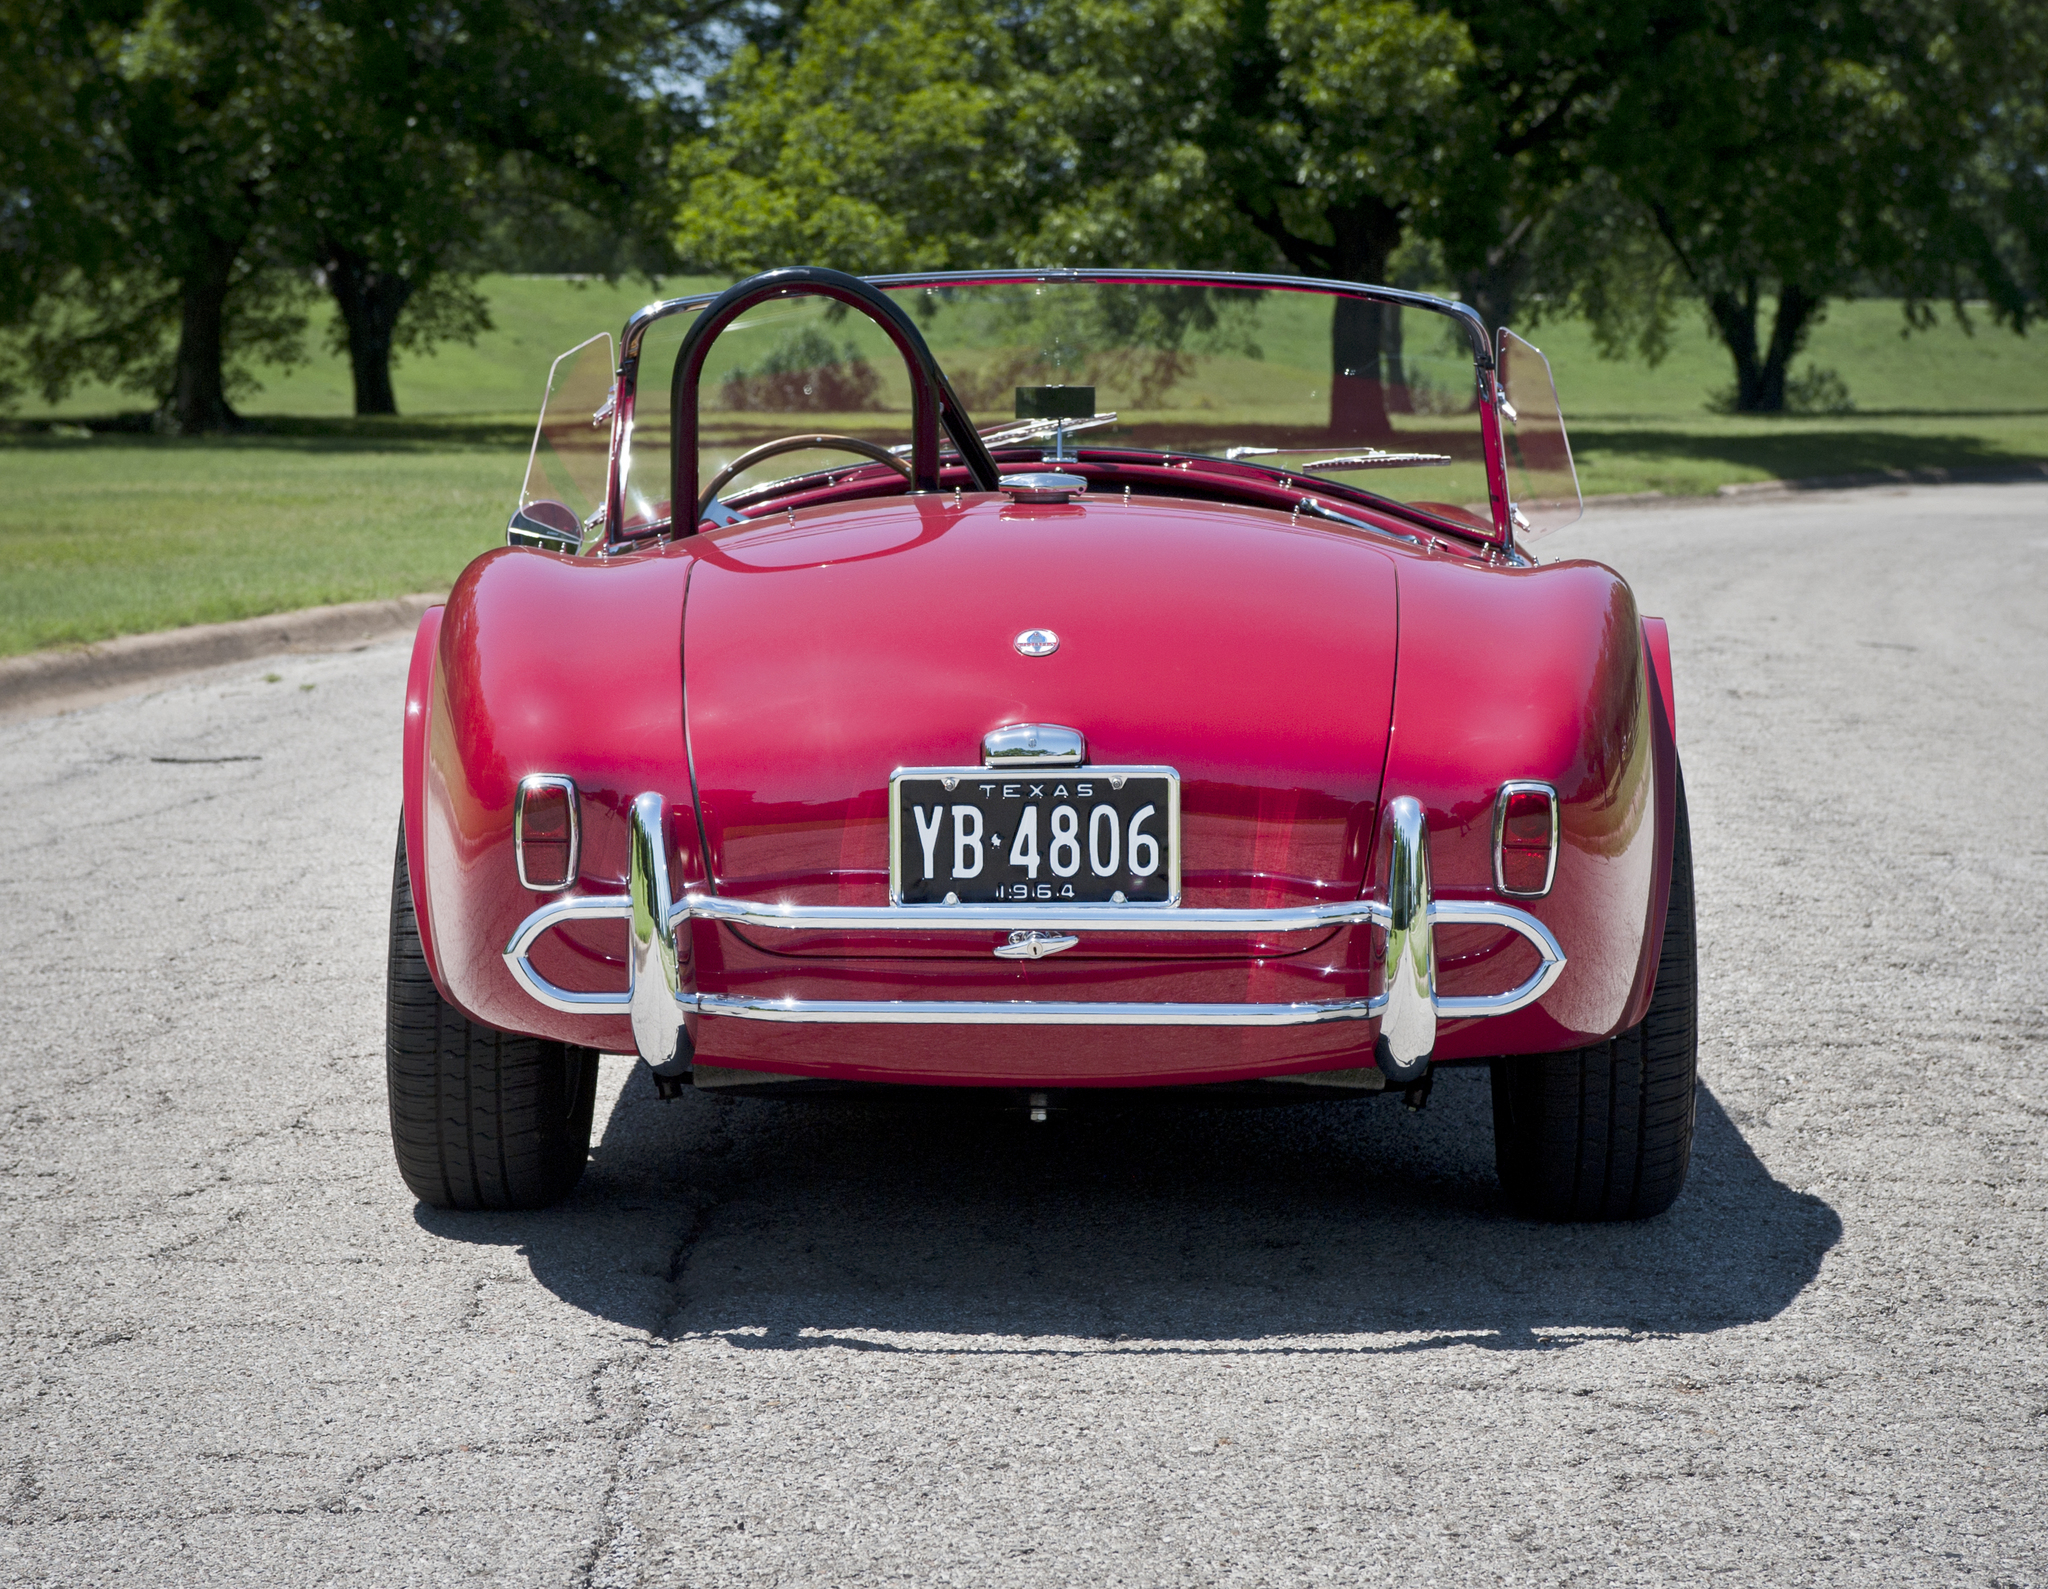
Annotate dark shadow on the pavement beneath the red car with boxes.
[418,1069,1841,1351]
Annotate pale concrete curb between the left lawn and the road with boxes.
[0,594,446,721]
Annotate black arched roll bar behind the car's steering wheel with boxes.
[668,264,1001,536]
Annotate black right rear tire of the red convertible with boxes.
[1493,778,1700,1220]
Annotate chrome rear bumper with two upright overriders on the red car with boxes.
[504,795,1565,1081]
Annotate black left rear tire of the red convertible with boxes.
[385,829,598,1208]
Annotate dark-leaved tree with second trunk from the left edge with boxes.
[283,0,737,414]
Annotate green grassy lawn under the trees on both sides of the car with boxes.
[0,276,2048,655]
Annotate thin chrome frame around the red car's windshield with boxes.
[604,266,1513,551]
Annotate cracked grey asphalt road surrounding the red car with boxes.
[0,485,2048,1589]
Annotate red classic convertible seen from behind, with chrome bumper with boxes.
[389,268,1696,1220]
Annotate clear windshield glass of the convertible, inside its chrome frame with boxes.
[621,278,1491,534]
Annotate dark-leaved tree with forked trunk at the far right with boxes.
[1546,0,2040,414]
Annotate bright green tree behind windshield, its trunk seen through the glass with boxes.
[678,0,1468,438]
